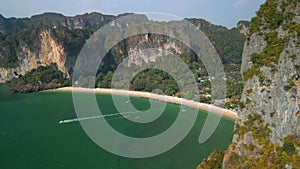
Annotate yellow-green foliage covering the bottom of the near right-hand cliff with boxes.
[226,114,300,168]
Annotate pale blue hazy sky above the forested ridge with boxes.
[0,0,265,28]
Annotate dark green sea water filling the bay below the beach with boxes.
[0,85,234,169]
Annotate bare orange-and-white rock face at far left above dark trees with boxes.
[0,30,68,82]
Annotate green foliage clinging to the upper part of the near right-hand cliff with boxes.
[244,0,300,81]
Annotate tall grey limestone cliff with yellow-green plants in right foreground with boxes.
[198,0,300,168]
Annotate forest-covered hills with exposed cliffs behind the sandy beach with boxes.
[0,12,249,107]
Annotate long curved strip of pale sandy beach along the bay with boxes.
[52,87,238,120]
